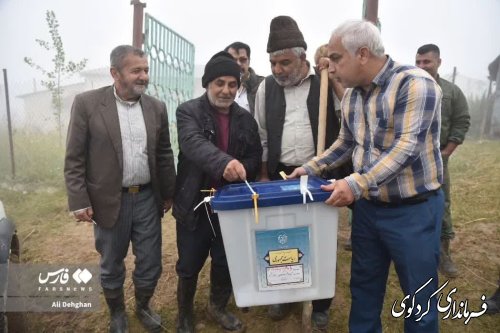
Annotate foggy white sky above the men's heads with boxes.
[0,0,500,94]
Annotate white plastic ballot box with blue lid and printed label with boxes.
[211,177,338,307]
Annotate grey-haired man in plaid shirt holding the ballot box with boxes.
[289,21,444,333]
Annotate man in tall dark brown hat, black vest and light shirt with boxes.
[255,16,340,329]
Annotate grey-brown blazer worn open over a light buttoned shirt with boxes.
[64,86,175,228]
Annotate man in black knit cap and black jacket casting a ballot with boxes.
[172,51,262,332]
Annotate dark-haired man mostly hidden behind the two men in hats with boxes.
[224,42,264,116]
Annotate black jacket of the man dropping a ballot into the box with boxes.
[172,94,262,230]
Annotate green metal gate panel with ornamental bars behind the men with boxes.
[144,14,194,157]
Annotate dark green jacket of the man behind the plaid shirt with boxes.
[437,76,470,148]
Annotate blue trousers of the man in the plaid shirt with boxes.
[349,190,444,333]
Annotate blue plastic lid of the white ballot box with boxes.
[211,176,331,210]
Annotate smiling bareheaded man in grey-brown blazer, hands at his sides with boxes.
[64,45,175,332]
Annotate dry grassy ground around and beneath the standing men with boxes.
[0,141,500,333]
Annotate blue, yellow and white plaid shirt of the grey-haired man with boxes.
[303,57,443,202]
